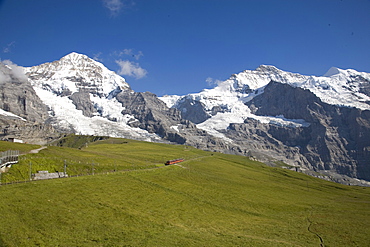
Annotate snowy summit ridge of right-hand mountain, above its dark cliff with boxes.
[163,65,370,111]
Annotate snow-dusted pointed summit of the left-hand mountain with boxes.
[25,52,130,97]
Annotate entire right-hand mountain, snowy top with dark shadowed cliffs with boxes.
[162,66,370,183]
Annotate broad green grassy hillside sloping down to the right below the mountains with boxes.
[0,139,370,246]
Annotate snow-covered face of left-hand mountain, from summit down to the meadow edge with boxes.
[25,52,158,140]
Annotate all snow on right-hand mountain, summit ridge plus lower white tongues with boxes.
[161,65,370,140]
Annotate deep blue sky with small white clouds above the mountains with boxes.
[0,0,370,96]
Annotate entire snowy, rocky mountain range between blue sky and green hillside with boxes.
[0,52,370,185]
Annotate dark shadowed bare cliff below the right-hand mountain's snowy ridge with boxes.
[247,82,370,180]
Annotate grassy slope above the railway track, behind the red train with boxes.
[0,135,205,184]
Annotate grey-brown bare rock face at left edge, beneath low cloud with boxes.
[0,63,59,144]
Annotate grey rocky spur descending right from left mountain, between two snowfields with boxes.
[117,91,231,151]
